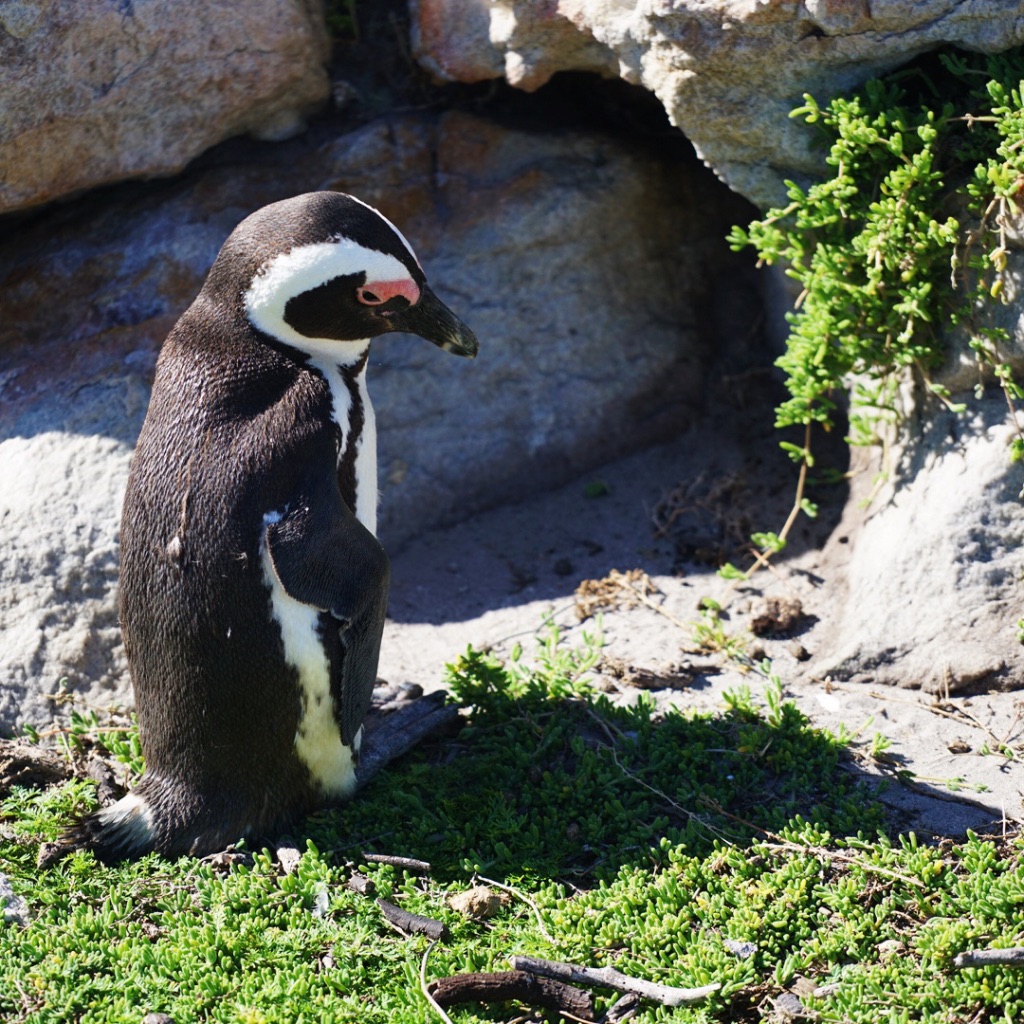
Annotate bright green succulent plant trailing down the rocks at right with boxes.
[724,49,1024,578]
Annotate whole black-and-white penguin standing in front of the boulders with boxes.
[71,191,478,862]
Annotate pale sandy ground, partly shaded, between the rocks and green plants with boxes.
[380,434,1024,836]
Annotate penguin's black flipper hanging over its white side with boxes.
[266,487,390,744]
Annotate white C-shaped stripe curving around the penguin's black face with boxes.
[242,236,415,366]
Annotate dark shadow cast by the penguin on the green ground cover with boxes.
[302,675,885,885]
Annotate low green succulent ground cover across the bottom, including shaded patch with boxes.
[0,640,1024,1024]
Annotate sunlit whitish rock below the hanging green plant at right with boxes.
[812,394,1024,693]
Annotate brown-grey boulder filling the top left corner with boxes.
[0,0,330,212]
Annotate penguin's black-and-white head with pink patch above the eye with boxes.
[206,191,478,362]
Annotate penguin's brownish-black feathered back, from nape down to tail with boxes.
[120,295,387,854]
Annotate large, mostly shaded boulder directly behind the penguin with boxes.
[0,114,756,729]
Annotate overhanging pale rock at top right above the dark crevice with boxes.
[414,0,1024,207]
